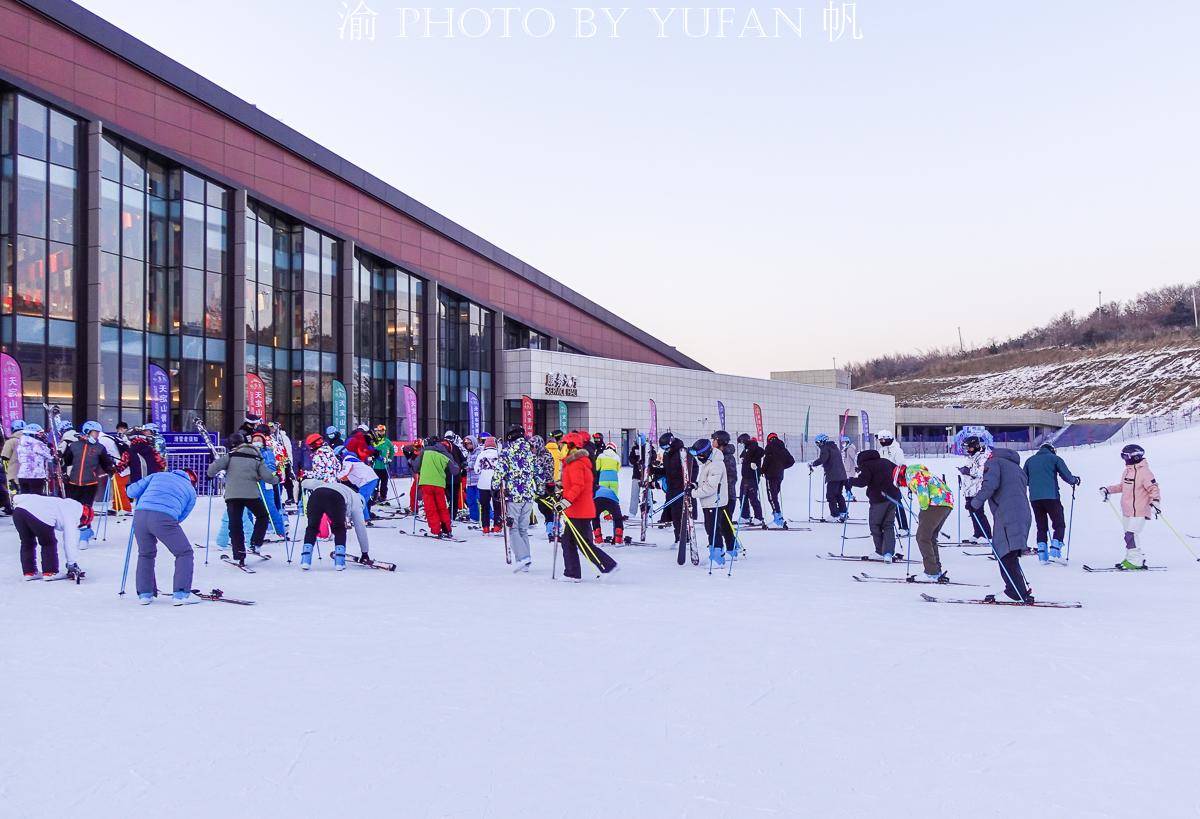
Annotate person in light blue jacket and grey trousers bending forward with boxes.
[127,470,199,605]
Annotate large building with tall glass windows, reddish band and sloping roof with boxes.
[0,0,703,438]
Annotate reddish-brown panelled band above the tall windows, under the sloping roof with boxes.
[0,0,676,365]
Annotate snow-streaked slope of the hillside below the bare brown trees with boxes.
[856,345,1200,419]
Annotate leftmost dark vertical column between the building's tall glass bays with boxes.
[82,121,102,418]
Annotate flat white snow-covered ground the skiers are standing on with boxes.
[0,430,1200,818]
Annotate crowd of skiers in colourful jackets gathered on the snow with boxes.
[0,408,1160,604]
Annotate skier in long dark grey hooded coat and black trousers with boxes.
[969,449,1033,603]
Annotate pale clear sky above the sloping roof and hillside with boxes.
[84,0,1200,375]
